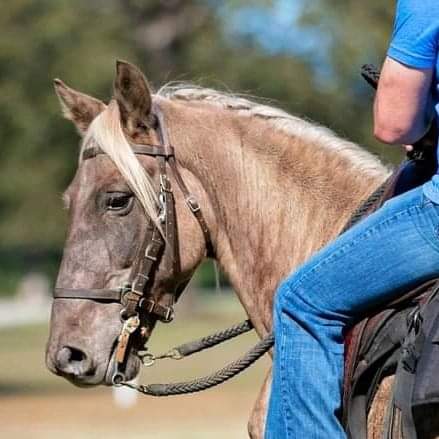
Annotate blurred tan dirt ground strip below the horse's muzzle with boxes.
[0,390,254,439]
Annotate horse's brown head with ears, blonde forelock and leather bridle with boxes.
[46,62,213,386]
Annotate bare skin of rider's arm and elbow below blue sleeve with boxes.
[374,57,434,144]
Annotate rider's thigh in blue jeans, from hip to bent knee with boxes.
[283,188,439,322]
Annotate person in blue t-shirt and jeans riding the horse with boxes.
[265,0,439,439]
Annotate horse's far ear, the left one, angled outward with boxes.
[53,79,105,135]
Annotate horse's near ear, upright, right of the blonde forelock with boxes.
[114,61,152,132]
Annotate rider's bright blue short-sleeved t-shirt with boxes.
[387,0,439,204]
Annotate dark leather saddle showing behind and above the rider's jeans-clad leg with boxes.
[343,148,439,439]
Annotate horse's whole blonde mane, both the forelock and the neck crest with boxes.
[81,85,385,225]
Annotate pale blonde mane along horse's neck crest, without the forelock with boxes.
[157,83,385,177]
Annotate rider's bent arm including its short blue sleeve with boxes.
[374,0,439,148]
